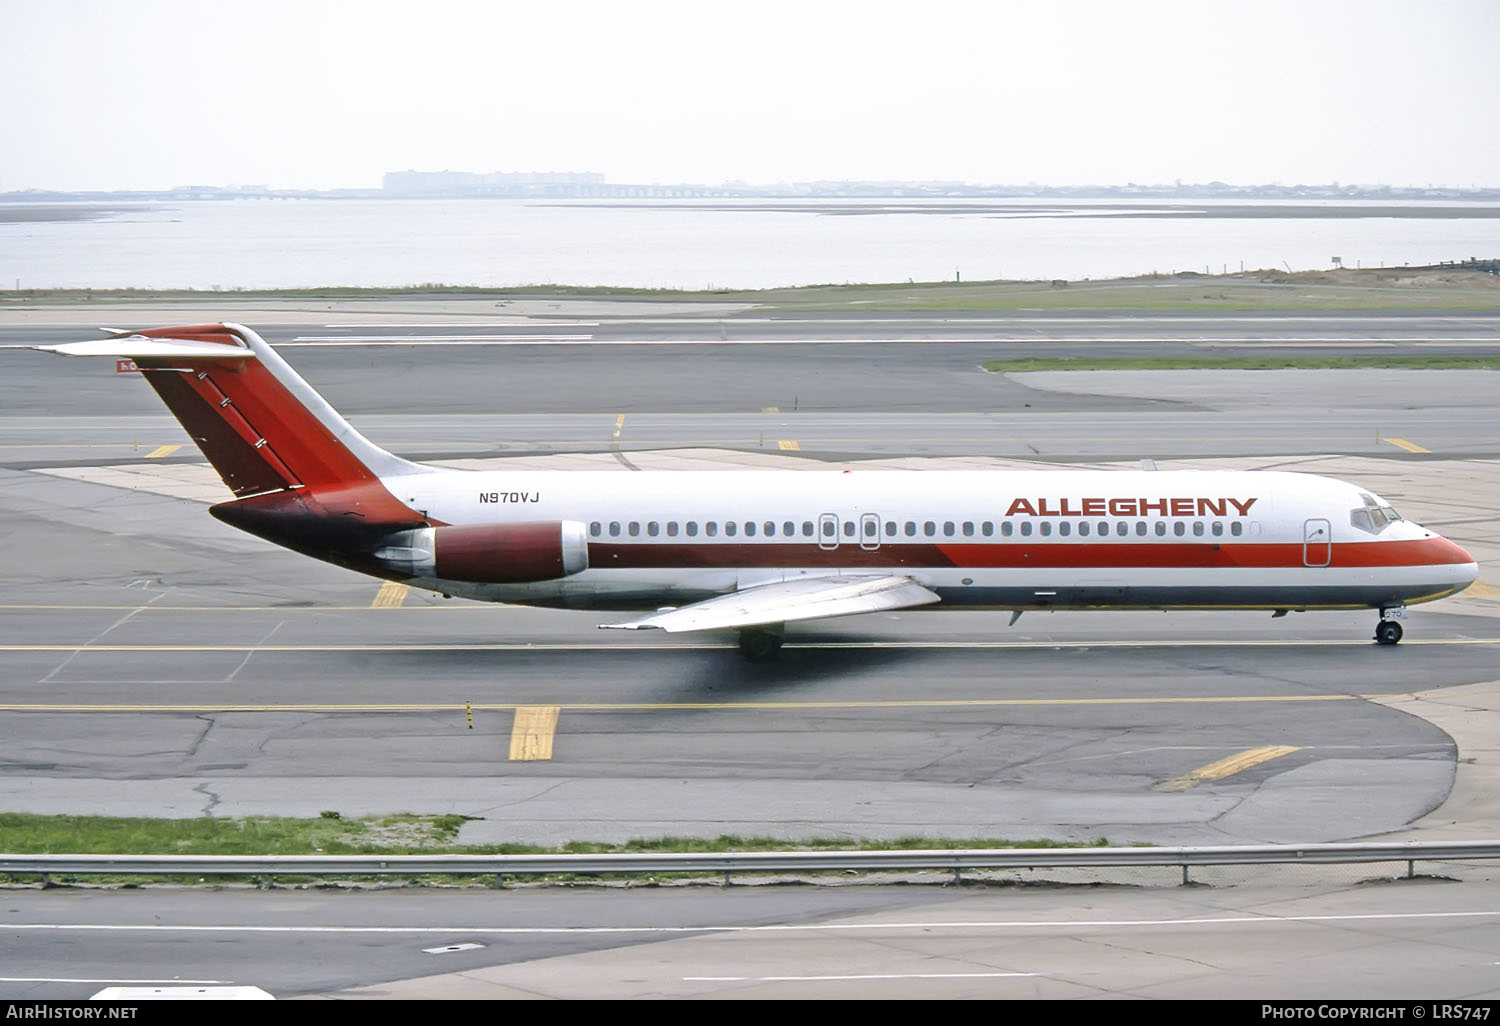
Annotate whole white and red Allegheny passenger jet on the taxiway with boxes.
[30,323,1479,662]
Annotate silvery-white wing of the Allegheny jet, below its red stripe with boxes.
[600,576,939,632]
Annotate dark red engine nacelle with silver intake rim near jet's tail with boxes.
[375,521,588,584]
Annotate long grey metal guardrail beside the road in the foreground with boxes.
[11,840,1500,882]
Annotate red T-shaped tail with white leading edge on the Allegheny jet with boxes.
[32,324,434,576]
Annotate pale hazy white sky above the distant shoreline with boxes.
[0,0,1500,192]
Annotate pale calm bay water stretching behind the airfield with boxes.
[0,200,1500,290]
